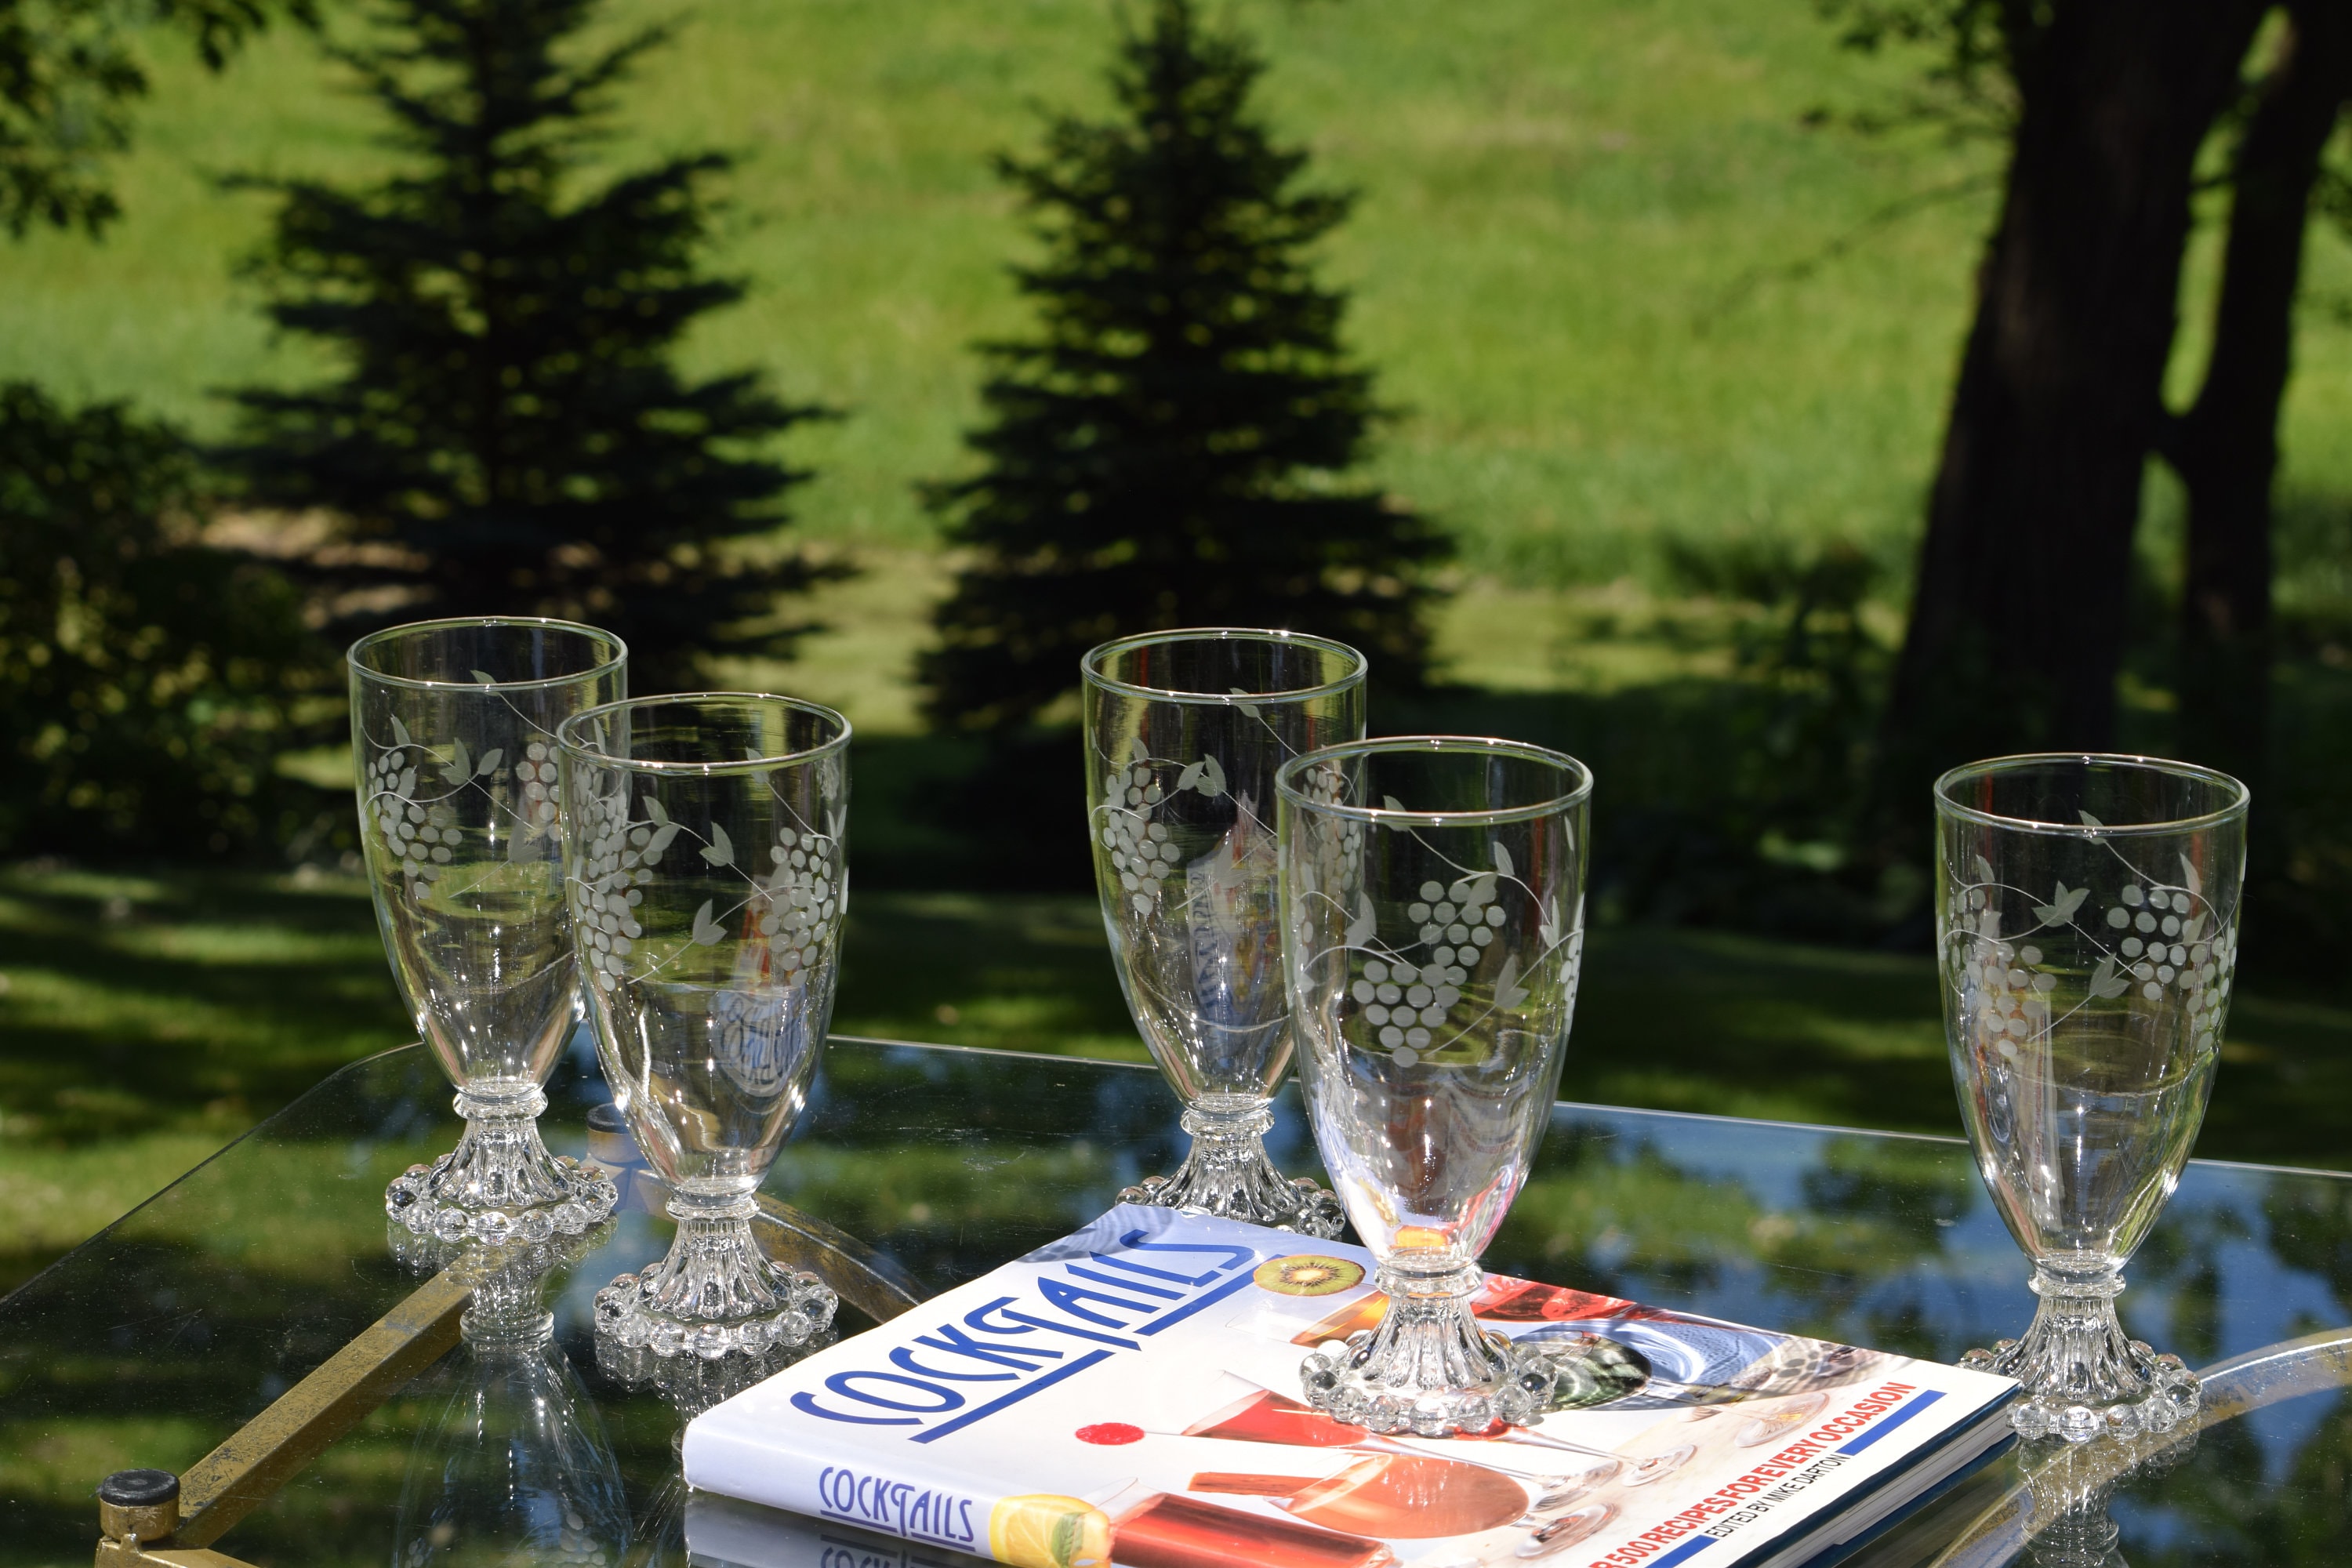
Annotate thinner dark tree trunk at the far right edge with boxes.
[2164,0,2352,799]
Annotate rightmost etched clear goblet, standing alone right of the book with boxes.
[1936,755,2246,1441]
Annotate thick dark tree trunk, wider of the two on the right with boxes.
[1882,0,2263,822]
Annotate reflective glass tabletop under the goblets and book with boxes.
[0,1039,2352,1568]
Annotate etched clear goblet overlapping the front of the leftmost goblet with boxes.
[562,694,849,1359]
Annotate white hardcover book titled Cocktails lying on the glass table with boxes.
[684,1206,2016,1568]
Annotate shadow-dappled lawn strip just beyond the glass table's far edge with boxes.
[0,867,2352,1288]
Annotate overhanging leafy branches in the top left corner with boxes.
[0,0,292,238]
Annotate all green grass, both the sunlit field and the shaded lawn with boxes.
[0,0,2352,1283]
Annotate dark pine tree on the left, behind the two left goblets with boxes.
[226,0,818,691]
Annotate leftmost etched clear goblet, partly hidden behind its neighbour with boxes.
[348,619,628,1246]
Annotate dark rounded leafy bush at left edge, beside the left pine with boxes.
[0,383,329,858]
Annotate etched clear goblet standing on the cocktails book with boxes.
[1277,736,1592,1436]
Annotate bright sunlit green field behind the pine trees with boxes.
[0,0,2352,625]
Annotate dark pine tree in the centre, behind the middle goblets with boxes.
[922,0,1444,729]
